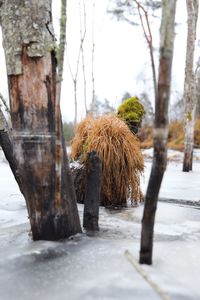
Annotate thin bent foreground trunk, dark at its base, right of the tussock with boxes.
[140,0,176,264]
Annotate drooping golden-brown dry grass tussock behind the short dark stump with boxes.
[71,115,144,206]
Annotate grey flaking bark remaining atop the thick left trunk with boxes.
[1,0,55,75]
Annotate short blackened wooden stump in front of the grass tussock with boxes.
[83,151,102,231]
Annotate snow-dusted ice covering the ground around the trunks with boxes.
[0,151,200,300]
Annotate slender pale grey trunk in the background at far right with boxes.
[183,0,199,172]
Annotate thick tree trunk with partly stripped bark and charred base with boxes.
[1,0,81,240]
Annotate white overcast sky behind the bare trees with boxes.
[0,0,200,121]
